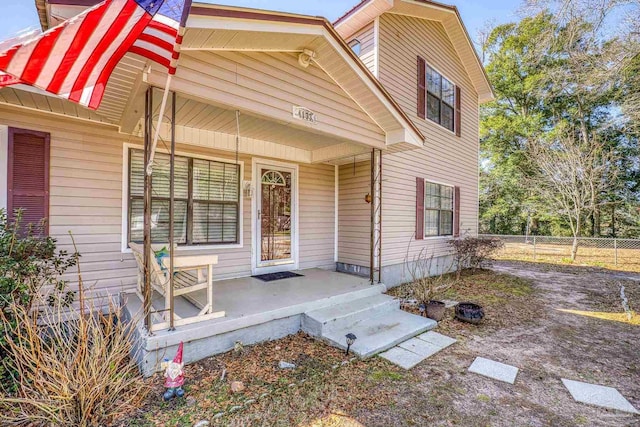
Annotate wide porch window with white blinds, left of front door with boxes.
[129,149,240,245]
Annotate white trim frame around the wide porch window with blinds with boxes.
[120,142,244,253]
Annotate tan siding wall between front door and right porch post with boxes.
[338,161,371,267]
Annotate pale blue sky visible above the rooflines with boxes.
[0,0,520,41]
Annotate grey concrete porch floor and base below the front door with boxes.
[123,268,386,375]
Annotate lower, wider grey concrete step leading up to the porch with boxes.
[322,309,438,358]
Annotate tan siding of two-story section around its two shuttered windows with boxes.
[379,14,478,265]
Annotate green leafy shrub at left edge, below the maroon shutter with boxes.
[0,210,78,392]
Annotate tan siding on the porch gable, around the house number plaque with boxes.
[158,52,385,149]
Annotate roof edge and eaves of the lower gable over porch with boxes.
[25,0,425,147]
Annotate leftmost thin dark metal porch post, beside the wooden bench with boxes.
[142,88,153,333]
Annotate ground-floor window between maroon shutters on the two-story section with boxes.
[424,181,454,236]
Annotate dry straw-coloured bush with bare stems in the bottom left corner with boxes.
[0,303,148,426]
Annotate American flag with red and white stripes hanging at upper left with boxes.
[0,0,191,110]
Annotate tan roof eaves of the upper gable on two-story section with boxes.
[333,0,494,103]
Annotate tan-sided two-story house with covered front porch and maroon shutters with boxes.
[0,0,493,373]
